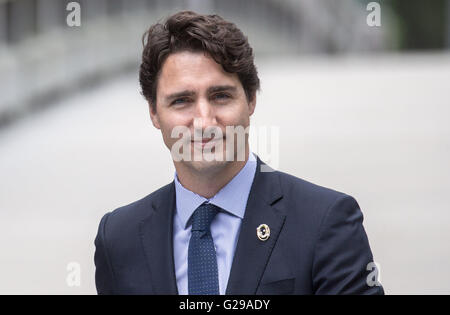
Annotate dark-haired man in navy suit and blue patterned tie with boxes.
[95,11,383,294]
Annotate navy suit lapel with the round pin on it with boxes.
[226,157,285,295]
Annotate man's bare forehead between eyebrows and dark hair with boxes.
[158,51,240,94]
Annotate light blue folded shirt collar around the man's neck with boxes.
[174,152,256,228]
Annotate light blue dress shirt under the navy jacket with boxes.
[173,152,256,295]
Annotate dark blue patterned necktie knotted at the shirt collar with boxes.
[188,203,220,295]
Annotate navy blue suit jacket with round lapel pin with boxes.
[95,158,384,295]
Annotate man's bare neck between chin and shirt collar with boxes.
[174,146,250,199]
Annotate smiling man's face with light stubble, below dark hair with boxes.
[150,51,256,172]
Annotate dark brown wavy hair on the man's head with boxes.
[139,11,259,111]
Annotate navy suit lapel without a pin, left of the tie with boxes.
[140,182,178,294]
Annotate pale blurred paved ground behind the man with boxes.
[0,55,450,294]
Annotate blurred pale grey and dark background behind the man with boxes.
[0,0,450,294]
